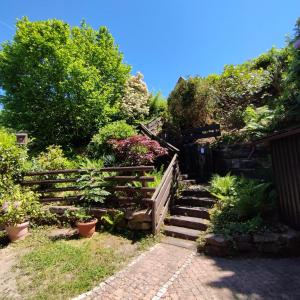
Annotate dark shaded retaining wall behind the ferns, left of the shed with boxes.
[213,144,272,179]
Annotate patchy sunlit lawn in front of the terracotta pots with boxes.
[0,228,158,299]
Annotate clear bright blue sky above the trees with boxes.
[0,0,300,97]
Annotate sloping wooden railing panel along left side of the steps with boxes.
[151,154,179,234]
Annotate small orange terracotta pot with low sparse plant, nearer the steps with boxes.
[65,208,98,238]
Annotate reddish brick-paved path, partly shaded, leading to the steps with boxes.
[77,239,300,300]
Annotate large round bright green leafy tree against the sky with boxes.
[0,18,130,147]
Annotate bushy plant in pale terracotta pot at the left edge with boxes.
[0,185,41,242]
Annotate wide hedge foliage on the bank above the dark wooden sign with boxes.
[168,47,291,135]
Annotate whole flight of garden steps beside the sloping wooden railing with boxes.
[164,175,215,241]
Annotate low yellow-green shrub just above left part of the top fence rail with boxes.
[33,145,73,170]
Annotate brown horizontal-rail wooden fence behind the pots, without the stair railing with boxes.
[21,166,155,206]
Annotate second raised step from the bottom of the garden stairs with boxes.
[165,215,210,231]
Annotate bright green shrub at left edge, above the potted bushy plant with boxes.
[0,129,27,187]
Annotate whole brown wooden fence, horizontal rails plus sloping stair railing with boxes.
[21,154,179,234]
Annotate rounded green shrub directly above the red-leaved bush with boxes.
[88,121,136,158]
